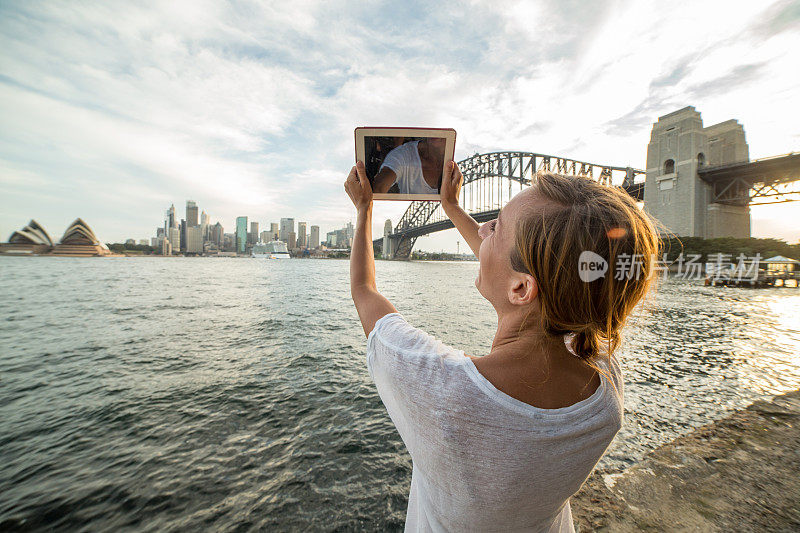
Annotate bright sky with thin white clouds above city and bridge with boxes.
[0,0,800,251]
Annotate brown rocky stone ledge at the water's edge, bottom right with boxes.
[571,390,800,533]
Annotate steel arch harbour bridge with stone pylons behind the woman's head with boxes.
[373,108,800,259]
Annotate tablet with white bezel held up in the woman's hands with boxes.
[355,128,456,201]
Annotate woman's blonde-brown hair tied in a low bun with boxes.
[511,172,660,369]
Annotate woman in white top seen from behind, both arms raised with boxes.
[345,162,658,531]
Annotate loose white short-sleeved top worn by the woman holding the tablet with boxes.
[367,313,623,532]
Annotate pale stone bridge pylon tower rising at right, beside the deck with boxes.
[644,106,750,239]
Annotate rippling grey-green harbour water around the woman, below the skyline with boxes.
[0,257,800,531]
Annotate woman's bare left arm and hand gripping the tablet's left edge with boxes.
[344,161,397,336]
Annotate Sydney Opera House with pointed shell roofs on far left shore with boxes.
[0,218,112,257]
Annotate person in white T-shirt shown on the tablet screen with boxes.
[372,137,446,194]
